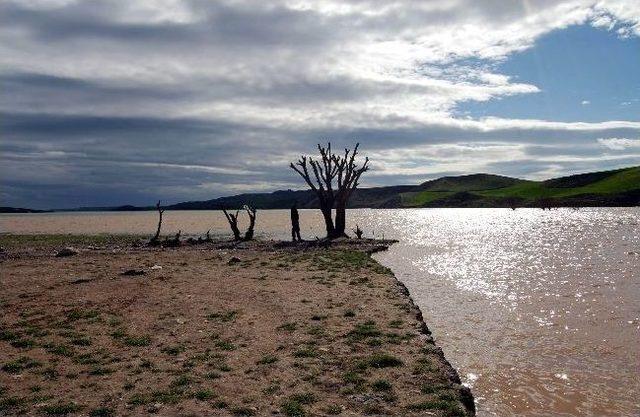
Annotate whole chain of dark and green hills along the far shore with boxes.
[3,166,640,212]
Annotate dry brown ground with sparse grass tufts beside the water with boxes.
[0,236,472,416]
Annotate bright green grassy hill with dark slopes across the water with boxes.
[401,167,640,207]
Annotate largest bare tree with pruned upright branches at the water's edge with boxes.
[290,143,369,239]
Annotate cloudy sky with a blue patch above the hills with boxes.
[0,0,640,208]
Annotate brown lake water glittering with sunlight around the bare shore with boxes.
[0,208,640,416]
